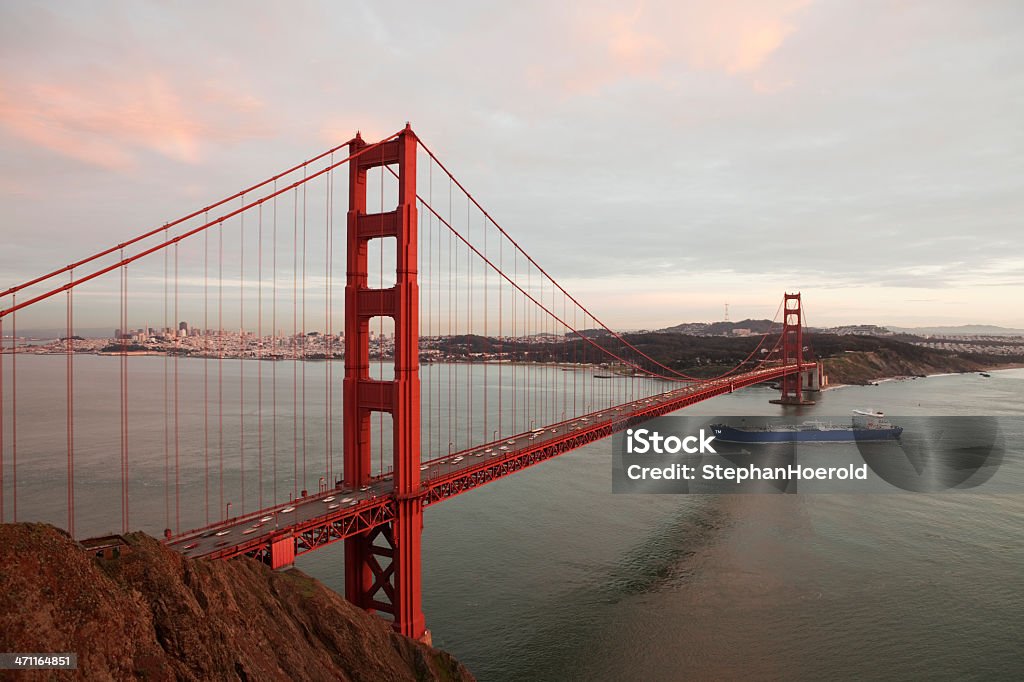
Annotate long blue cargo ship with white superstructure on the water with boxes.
[711,410,903,443]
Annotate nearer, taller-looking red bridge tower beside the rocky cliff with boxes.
[344,125,429,641]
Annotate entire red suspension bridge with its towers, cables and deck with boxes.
[0,124,822,641]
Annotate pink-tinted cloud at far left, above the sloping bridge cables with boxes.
[0,74,267,170]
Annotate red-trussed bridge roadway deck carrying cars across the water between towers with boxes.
[167,363,815,565]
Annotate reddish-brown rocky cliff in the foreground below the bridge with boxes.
[0,523,473,681]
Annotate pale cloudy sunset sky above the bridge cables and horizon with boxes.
[0,0,1024,329]
